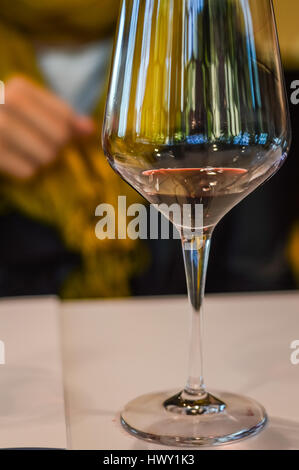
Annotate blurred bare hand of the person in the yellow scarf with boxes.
[0,76,95,180]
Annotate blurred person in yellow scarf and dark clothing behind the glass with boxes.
[0,0,147,298]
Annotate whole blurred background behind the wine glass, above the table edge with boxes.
[0,0,299,299]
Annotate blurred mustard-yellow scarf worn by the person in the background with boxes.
[0,0,147,298]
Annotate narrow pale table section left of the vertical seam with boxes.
[0,298,67,448]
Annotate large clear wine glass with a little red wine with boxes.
[103,0,291,446]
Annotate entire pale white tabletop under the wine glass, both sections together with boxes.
[0,292,299,450]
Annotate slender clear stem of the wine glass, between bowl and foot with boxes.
[182,230,213,399]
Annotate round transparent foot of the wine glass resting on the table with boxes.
[121,392,267,447]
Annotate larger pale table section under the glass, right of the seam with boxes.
[62,293,299,450]
